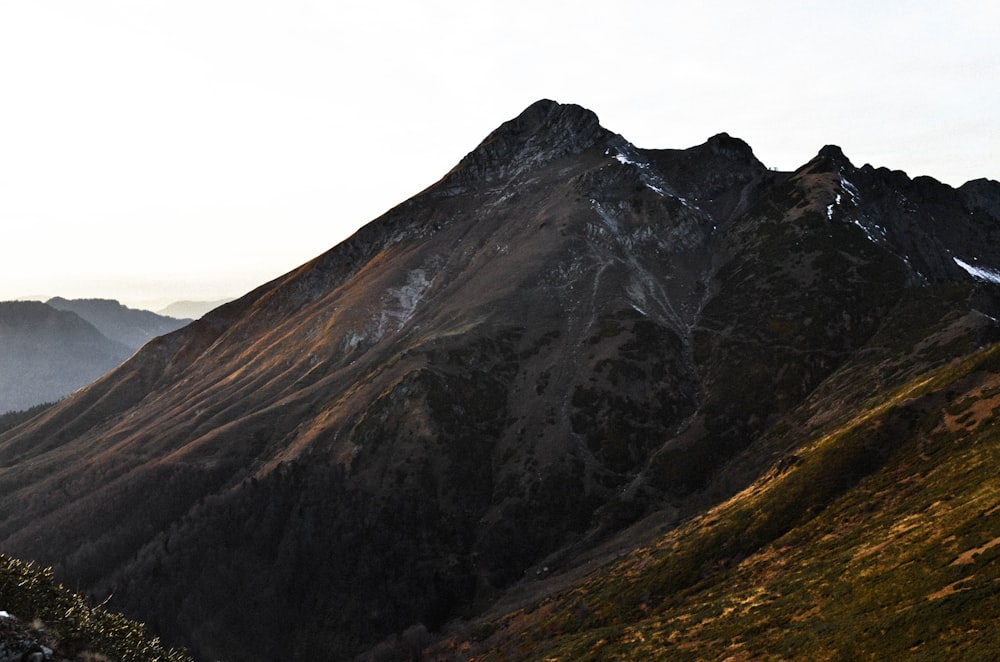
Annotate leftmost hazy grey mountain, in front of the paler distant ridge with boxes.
[0,301,133,413]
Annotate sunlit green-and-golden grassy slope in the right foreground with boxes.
[424,345,1000,662]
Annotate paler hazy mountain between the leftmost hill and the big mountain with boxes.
[46,297,191,350]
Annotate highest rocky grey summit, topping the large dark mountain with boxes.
[446,99,611,185]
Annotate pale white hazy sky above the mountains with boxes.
[0,0,1000,307]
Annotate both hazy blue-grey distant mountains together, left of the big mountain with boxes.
[0,297,191,413]
